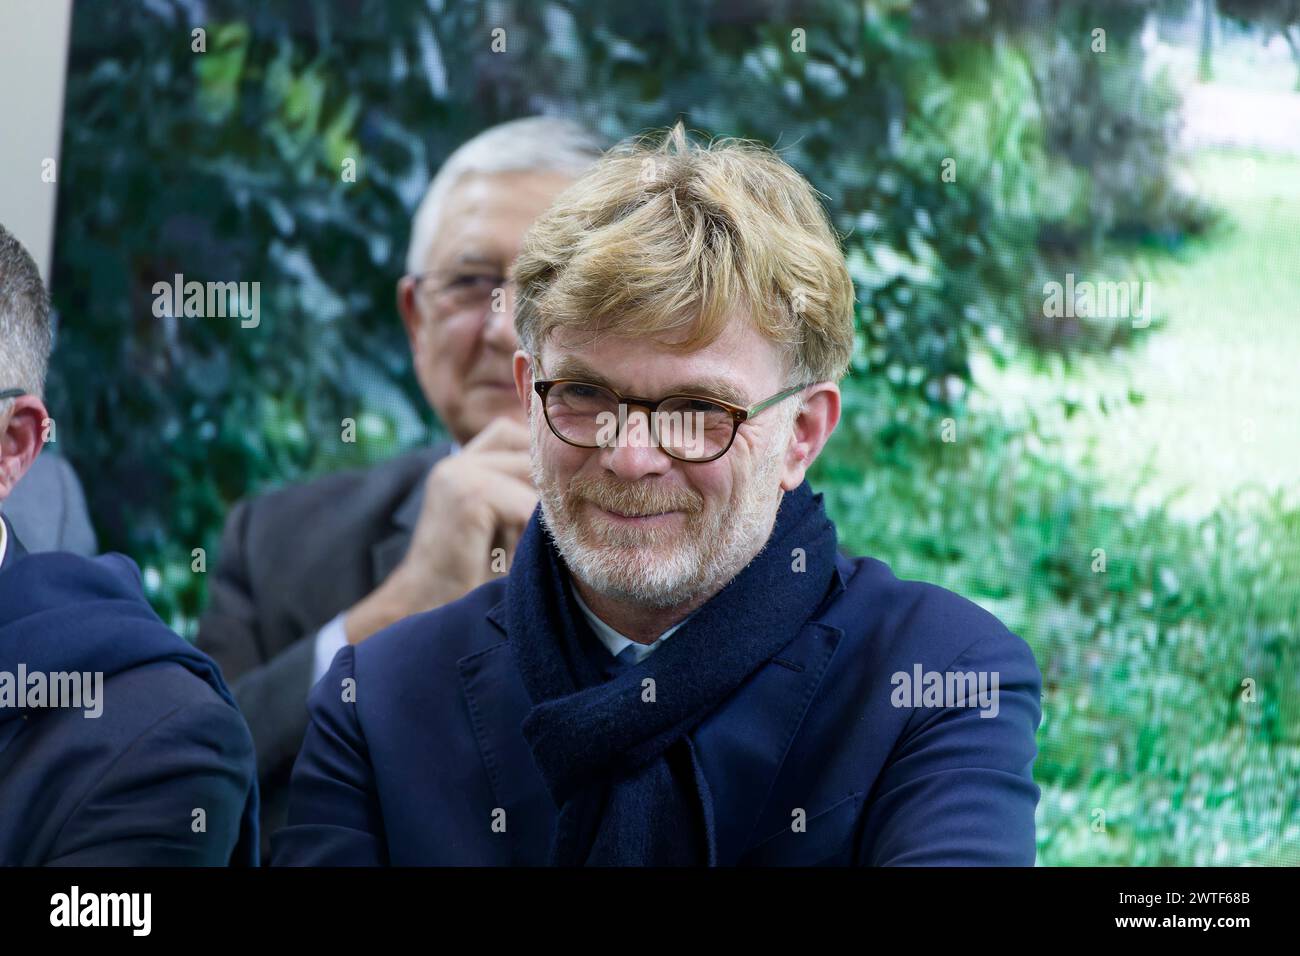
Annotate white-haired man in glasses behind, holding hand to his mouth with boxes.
[198,117,601,857]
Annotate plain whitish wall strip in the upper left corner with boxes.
[0,0,72,285]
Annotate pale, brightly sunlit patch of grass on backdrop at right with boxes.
[972,151,1300,518]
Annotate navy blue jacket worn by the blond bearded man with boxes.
[273,546,1041,866]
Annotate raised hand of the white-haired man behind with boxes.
[343,419,537,644]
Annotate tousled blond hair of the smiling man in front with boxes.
[515,124,854,384]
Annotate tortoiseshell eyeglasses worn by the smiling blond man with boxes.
[533,378,811,464]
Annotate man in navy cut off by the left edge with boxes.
[0,226,259,866]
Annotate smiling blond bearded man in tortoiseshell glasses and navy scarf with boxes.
[274,126,1041,865]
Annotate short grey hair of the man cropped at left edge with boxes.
[0,225,52,410]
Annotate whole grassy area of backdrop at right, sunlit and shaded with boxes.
[814,145,1300,865]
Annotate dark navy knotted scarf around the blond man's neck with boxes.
[506,481,836,866]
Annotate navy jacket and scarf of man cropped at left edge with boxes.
[0,520,256,866]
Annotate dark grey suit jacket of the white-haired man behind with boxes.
[196,445,450,860]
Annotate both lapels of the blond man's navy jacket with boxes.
[475,555,852,866]
